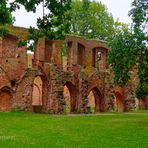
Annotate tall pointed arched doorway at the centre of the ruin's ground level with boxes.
[63,82,78,113]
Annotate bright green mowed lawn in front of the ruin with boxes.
[0,111,148,148]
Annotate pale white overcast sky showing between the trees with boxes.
[13,0,133,27]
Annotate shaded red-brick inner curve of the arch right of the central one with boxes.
[87,87,104,112]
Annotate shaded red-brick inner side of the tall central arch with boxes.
[63,82,78,113]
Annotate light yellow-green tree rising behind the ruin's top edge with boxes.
[69,0,115,40]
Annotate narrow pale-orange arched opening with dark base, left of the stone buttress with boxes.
[32,76,43,112]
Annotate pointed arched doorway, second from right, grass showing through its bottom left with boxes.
[87,87,104,113]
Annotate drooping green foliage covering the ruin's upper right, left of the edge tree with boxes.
[108,28,135,86]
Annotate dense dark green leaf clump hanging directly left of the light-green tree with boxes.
[37,0,71,39]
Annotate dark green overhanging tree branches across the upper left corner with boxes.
[0,0,71,50]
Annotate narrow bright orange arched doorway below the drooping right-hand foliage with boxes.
[115,88,124,112]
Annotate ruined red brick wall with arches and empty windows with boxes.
[0,26,146,114]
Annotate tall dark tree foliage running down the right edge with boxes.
[129,0,148,99]
